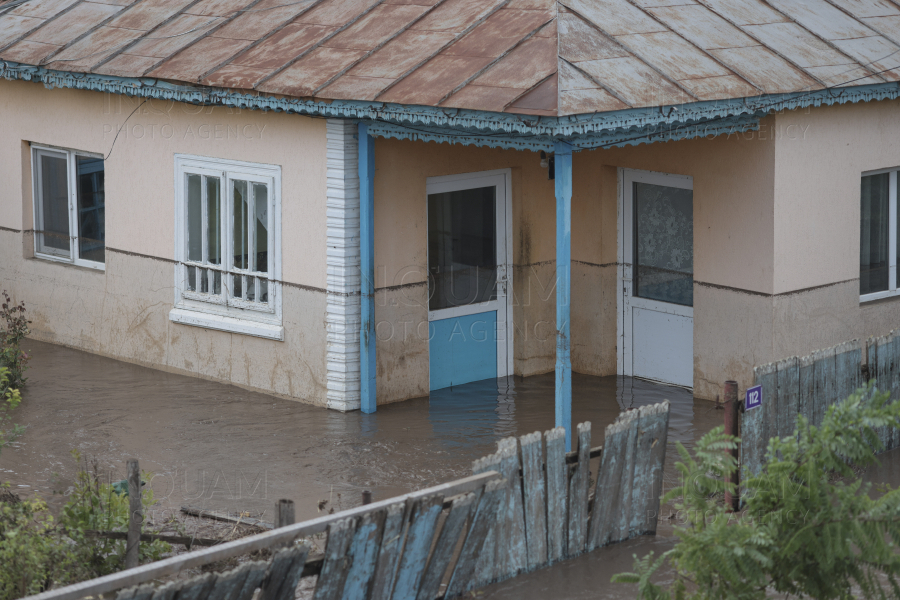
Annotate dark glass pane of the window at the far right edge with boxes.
[859,173,890,294]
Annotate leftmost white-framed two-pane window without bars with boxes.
[31,145,106,269]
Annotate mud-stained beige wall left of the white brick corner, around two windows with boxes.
[0,82,326,404]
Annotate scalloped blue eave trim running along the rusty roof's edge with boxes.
[0,61,900,143]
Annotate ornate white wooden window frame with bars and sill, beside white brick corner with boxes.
[169,154,284,341]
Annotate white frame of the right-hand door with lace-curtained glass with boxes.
[616,167,694,385]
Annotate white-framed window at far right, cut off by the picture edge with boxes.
[859,170,900,301]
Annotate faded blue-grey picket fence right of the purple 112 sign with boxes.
[740,330,900,473]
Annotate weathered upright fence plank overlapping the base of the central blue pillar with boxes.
[544,427,568,563]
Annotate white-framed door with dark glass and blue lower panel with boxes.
[427,169,512,390]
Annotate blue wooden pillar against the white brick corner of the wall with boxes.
[358,123,377,413]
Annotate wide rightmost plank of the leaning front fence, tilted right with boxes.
[630,400,669,537]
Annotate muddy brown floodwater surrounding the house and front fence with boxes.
[0,340,723,598]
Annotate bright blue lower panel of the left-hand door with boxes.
[428,310,497,390]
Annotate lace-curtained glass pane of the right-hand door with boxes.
[634,183,694,306]
